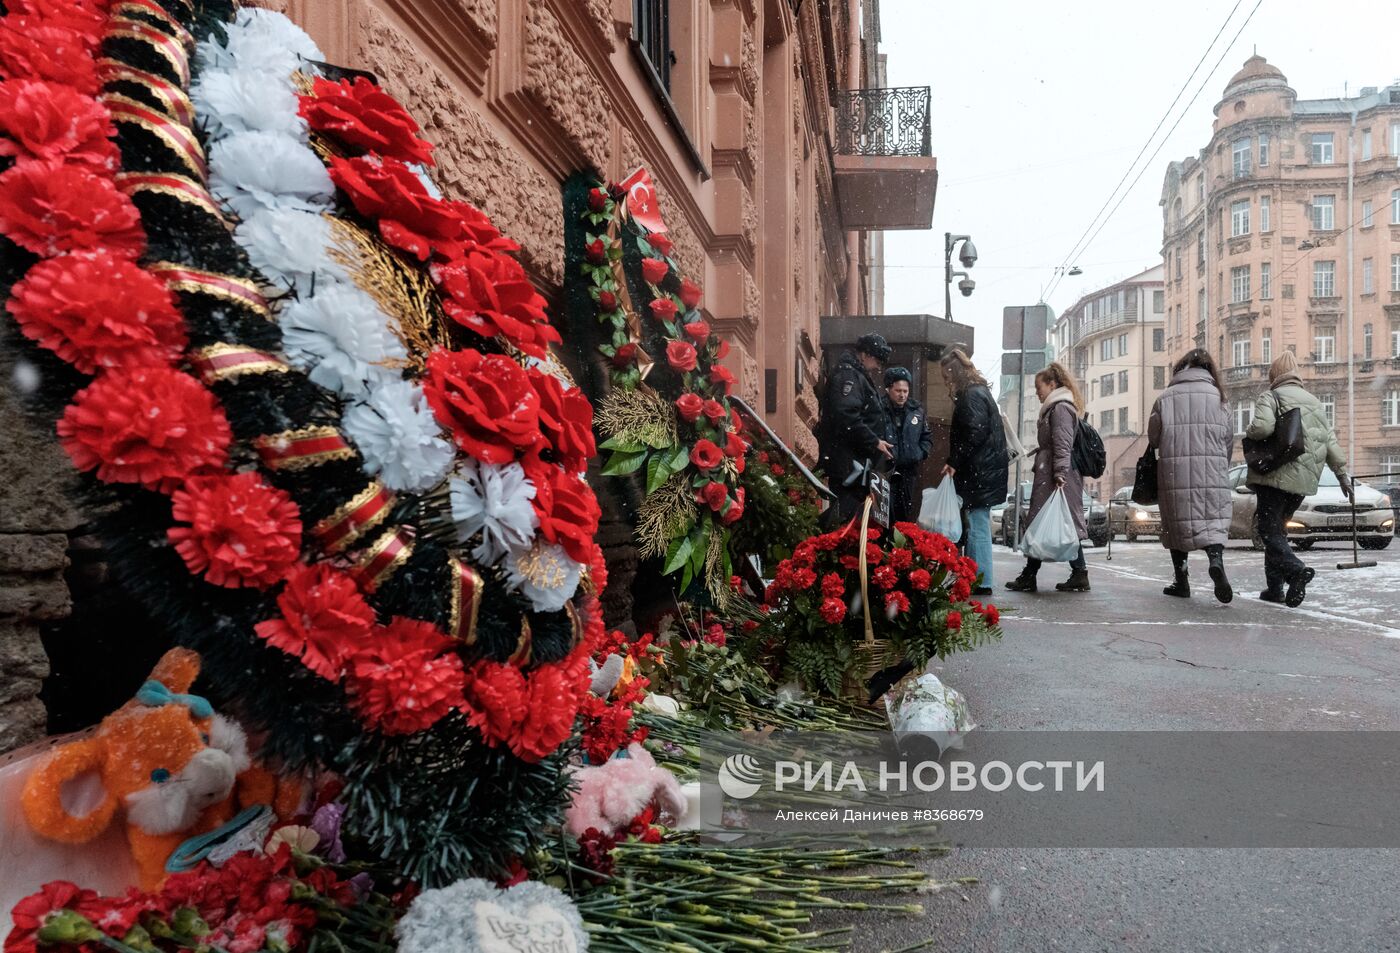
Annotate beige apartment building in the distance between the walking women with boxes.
[1051,264,1173,489]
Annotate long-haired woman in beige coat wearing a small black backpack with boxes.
[1007,361,1089,592]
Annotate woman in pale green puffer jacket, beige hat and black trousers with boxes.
[1245,351,1352,609]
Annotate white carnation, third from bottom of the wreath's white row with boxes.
[342,381,455,493]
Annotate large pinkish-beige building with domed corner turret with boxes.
[1161,55,1400,474]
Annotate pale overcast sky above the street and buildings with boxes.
[879,0,1400,371]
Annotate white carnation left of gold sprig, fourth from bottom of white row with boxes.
[280,281,407,397]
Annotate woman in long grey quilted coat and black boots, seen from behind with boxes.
[1147,347,1235,602]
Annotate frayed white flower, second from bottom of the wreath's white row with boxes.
[451,460,539,565]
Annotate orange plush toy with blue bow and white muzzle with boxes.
[22,648,300,890]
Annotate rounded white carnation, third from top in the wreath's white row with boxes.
[209,132,335,218]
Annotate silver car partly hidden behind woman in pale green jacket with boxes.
[1229,465,1396,550]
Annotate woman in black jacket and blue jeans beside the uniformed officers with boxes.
[938,347,1011,596]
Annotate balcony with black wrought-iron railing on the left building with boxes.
[832,87,938,231]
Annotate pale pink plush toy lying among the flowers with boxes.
[564,744,686,837]
